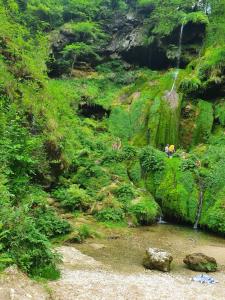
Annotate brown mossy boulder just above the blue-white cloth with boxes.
[183,253,217,272]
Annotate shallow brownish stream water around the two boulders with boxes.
[76,224,225,274]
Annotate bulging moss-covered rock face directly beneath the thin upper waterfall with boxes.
[109,70,182,149]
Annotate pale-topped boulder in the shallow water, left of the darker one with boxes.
[143,248,173,272]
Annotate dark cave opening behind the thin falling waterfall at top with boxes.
[120,22,206,70]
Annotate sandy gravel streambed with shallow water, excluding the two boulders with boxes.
[0,225,225,300]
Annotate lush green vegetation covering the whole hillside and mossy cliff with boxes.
[0,0,225,279]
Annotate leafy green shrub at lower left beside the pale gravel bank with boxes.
[0,207,59,279]
